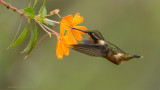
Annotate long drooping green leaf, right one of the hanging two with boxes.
[21,25,37,56]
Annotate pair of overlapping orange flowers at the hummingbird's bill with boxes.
[56,13,87,59]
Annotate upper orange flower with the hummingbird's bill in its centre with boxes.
[60,13,87,44]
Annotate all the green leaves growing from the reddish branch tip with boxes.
[10,0,54,57]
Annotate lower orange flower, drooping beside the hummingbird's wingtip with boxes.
[56,35,69,59]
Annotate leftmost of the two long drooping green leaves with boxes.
[10,23,29,47]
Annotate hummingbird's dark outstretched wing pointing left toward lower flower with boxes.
[72,44,107,57]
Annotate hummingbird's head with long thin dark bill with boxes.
[72,28,105,44]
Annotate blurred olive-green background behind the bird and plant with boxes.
[0,0,160,90]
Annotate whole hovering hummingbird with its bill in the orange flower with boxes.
[72,28,143,65]
